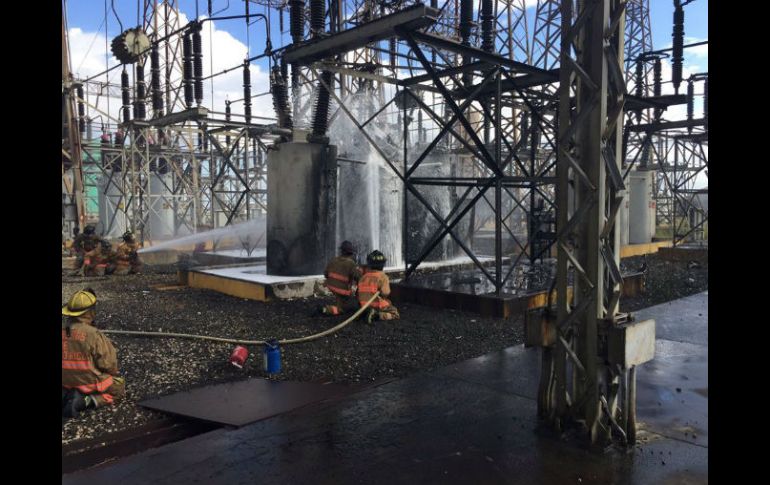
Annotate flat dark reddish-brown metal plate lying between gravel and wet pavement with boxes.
[139,379,366,426]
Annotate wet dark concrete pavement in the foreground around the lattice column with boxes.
[62,292,708,484]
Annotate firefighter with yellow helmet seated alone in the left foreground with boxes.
[61,288,125,418]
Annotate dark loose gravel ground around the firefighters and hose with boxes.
[62,251,708,444]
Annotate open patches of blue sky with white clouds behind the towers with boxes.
[65,0,708,129]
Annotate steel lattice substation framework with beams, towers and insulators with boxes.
[62,0,708,443]
